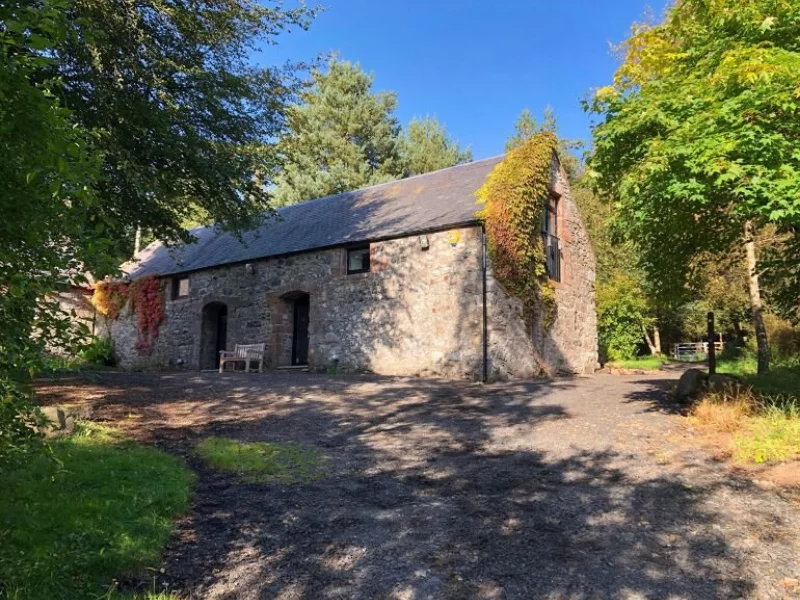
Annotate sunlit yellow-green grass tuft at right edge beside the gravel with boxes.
[733,403,800,463]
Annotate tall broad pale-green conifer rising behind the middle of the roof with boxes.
[275,58,403,206]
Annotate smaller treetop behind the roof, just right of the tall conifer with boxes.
[402,117,472,176]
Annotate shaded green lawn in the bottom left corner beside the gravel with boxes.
[0,424,193,600]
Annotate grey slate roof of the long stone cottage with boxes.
[122,156,502,277]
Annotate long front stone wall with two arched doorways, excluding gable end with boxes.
[110,227,482,377]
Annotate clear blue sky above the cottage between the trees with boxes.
[257,0,666,159]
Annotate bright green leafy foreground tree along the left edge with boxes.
[0,0,106,468]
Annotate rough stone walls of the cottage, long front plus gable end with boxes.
[110,158,597,378]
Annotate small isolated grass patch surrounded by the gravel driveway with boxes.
[197,437,322,483]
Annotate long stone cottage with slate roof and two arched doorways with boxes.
[114,157,597,379]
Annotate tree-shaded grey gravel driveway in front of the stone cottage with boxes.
[40,373,800,600]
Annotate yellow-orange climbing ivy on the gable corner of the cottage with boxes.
[477,131,558,327]
